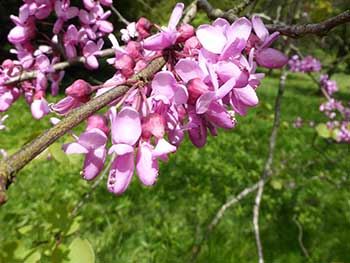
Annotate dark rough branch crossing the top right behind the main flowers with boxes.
[198,0,350,38]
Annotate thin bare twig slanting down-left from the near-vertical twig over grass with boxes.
[191,181,261,262]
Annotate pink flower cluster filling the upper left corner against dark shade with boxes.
[0,0,113,119]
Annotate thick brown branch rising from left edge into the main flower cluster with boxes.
[0,57,166,205]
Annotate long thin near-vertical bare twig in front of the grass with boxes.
[253,67,288,263]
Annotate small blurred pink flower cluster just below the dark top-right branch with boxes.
[288,55,321,73]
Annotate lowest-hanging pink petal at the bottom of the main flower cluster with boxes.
[107,152,134,195]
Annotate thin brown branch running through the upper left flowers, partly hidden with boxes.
[4,48,115,85]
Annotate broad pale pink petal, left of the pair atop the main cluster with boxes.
[196,25,227,54]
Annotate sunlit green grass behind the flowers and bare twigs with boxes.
[0,72,350,263]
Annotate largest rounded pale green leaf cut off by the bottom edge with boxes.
[68,237,95,263]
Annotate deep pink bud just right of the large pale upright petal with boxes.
[141,113,165,139]
